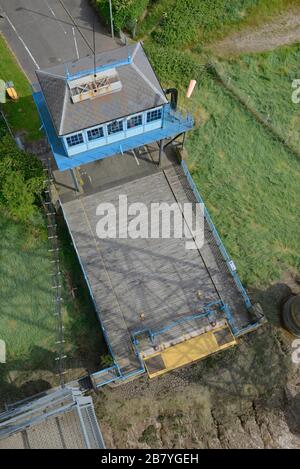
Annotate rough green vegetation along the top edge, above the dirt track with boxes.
[138,0,299,50]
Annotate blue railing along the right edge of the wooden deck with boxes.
[181,161,252,308]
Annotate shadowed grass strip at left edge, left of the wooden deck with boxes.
[0,209,57,404]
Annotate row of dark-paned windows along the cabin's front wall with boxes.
[66,109,162,147]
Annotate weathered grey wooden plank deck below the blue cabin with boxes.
[54,144,255,376]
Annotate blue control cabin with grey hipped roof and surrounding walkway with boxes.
[34,43,193,170]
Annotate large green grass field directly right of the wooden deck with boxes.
[187,76,300,286]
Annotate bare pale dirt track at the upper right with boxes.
[211,10,300,55]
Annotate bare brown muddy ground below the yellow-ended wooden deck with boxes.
[95,318,300,449]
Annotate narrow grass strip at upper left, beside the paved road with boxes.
[0,35,42,140]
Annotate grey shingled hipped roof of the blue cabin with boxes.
[36,43,167,135]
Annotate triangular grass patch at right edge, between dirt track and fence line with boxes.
[213,44,300,151]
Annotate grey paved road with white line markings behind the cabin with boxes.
[0,0,117,82]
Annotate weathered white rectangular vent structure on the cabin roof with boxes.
[68,68,122,103]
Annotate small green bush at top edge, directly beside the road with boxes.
[93,0,150,30]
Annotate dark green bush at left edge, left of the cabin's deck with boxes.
[0,135,44,221]
